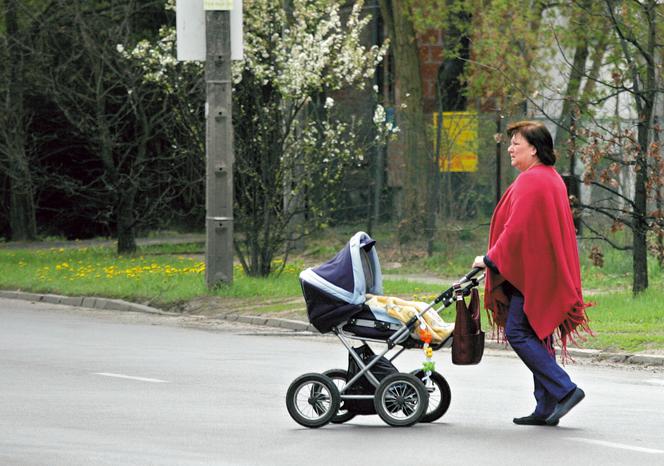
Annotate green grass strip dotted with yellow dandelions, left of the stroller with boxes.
[0,245,308,304]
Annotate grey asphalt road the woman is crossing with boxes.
[0,300,664,466]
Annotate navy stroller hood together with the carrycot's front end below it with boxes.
[300,231,383,333]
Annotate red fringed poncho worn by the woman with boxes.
[484,165,590,350]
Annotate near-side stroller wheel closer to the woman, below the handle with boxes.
[374,373,429,427]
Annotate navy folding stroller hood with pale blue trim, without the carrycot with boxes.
[300,231,383,304]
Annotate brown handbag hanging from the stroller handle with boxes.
[452,288,484,366]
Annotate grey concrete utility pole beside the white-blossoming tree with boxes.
[205,10,235,288]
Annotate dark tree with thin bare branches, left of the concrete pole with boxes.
[36,0,188,253]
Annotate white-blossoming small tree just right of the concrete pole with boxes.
[233,0,391,275]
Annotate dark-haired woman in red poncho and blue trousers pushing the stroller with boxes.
[473,121,590,426]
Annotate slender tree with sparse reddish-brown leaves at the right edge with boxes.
[581,0,664,294]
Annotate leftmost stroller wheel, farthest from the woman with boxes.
[286,373,340,428]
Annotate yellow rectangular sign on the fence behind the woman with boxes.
[433,112,478,172]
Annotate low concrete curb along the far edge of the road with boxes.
[0,290,664,366]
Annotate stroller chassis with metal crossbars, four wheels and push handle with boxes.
[286,268,484,428]
